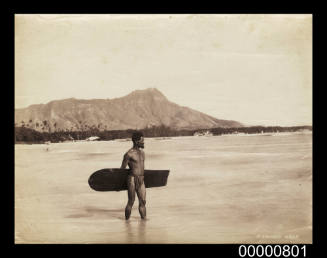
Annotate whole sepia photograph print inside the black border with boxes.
[14,14,313,244]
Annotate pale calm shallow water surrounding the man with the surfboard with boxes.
[15,134,312,243]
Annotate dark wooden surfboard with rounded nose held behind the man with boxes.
[88,168,169,191]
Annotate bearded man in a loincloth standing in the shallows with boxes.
[120,132,146,220]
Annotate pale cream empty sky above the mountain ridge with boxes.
[15,14,312,126]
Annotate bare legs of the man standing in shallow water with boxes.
[125,176,146,220]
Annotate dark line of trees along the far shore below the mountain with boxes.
[15,125,312,143]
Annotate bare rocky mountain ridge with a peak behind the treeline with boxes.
[15,88,242,132]
